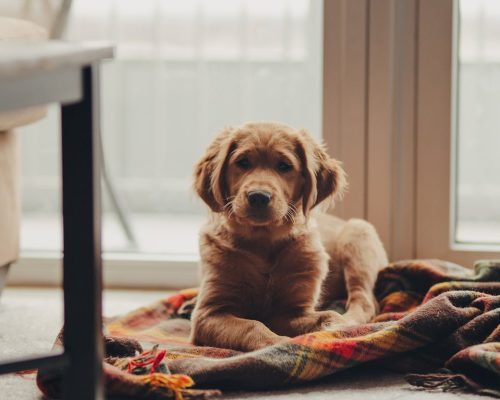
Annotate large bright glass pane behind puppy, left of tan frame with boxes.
[18,0,322,253]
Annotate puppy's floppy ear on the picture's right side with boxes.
[297,131,347,215]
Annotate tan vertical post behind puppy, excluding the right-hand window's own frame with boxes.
[323,0,418,259]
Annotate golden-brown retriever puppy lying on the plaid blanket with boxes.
[191,122,387,351]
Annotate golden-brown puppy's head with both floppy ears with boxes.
[194,123,345,227]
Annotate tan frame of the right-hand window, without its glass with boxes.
[416,0,500,265]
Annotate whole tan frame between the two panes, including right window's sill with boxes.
[323,0,500,266]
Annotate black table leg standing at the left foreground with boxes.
[61,66,104,400]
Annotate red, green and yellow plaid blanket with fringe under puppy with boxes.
[37,260,500,399]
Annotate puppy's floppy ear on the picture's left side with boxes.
[194,128,234,212]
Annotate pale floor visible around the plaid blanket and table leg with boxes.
[0,288,485,400]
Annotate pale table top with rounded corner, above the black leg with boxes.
[0,41,113,80]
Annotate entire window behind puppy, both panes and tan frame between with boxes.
[12,0,500,285]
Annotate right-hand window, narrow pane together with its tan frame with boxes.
[416,0,500,266]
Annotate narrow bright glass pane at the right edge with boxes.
[455,0,500,244]
